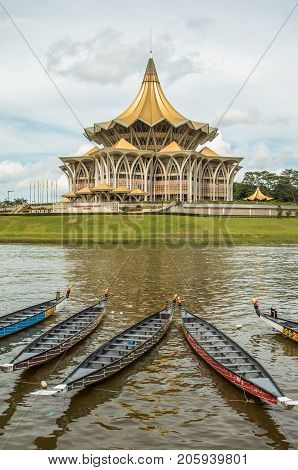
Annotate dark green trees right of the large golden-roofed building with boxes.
[234,170,298,203]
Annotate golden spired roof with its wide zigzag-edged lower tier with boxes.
[85,58,217,152]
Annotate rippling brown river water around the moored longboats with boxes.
[0,244,298,449]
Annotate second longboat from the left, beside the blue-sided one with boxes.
[0,296,108,372]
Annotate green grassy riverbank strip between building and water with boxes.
[0,214,298,244]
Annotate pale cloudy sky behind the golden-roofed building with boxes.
[0,0,298,200]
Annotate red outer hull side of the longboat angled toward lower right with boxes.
[183,325,277,405]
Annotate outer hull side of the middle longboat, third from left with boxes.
[65,321,171,390]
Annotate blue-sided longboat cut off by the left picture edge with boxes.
[0,289,70,338]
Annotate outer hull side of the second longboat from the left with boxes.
[13,313,103,371]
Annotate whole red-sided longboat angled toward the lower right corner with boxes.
[180,307,298,408]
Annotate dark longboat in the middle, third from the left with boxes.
[31,302,175,396]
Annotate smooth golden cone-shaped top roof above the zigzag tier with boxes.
[114,58,188,126]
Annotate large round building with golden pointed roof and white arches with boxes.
[61,58,242,202]
